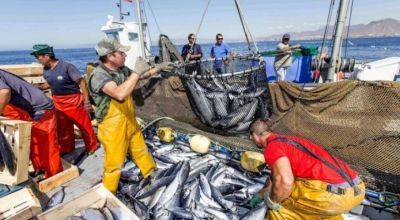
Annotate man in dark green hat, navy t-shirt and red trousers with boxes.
[31,44,98,154]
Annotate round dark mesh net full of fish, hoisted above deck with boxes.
[178,57,271,133]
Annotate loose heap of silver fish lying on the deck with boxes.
[117,133,268,220]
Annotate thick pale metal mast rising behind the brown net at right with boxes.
[325,0,349,82]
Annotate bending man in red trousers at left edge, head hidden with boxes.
[0,70,63,178]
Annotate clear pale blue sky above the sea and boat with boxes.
[0,0,400,51]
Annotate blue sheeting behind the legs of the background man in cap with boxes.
[264,56,313,83]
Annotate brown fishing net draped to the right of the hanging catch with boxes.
[269,80,400,193]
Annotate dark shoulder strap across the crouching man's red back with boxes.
[270,137,355,187]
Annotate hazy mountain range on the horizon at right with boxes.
[257,18,400,41]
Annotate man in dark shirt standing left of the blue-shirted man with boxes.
[181,33,203,74]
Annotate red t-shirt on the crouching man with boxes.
[264,134,357,184]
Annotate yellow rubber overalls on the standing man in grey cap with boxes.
[98,96,156,193]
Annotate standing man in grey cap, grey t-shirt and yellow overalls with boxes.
[89,39,173,193]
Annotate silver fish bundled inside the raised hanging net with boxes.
[186,78,269,133]
